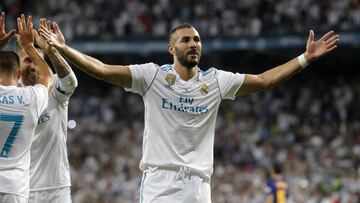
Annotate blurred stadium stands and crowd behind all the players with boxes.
[0,0,360,203]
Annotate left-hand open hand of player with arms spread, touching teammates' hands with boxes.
[39,22,66,49]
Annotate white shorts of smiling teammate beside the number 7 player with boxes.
[29,187,72,203]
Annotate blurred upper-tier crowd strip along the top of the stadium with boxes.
[0,0,360,41]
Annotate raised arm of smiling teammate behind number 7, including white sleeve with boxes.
[35,18,78,95]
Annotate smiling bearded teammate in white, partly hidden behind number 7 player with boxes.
[15,19,77,203]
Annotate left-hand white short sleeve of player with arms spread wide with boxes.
[125,63,158,96]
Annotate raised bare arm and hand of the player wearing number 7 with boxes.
[17,14,52,91]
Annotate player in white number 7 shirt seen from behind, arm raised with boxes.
[0,14,51,203]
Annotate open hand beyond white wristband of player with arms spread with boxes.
[304,30,340,62]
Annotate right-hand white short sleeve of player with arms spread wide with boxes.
[216,70,245,100]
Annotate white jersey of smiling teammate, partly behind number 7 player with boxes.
[30,75,75,191]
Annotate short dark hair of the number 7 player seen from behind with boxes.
[0,51,20,74]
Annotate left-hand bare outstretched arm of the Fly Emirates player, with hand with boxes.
[40,22,131,88]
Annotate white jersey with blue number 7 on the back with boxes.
[0,85,48,198]
